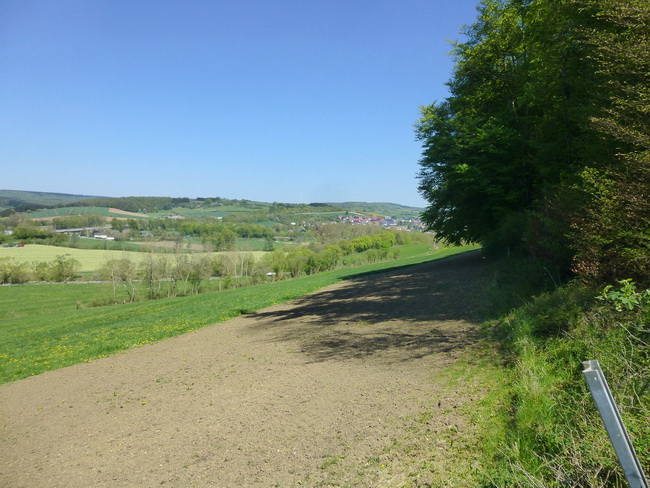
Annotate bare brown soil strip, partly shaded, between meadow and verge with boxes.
[0,253,483,488]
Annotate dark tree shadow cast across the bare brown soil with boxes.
[243,251,486,361]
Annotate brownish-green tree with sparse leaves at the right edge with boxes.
[573,0,650,284]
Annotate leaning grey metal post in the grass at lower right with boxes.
[582,360,648,488]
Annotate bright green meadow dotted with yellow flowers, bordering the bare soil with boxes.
[0,247,476,383]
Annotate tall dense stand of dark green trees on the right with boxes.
[416,0,650,281]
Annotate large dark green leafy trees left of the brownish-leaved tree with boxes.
[416,0,596,267]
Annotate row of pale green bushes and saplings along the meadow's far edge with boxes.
[67,231,399,305]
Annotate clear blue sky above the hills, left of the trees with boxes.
[0,0,477,206]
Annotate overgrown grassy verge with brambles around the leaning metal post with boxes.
[484,260,650,488]
